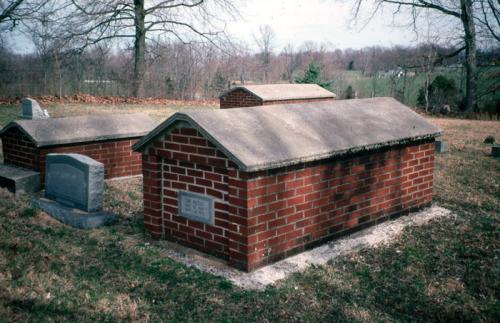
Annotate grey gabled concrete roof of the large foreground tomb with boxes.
[133,98,441,171]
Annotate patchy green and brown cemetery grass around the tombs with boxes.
[0,105,500,322]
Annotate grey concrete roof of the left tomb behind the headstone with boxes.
[0,114,158,147]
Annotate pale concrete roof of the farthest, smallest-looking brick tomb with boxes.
[220,84,336,101]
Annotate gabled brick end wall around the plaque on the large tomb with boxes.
[143,128,246,259]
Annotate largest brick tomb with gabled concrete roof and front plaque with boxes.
[133,98,440,271]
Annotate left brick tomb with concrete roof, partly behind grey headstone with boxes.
[0,114,157,183]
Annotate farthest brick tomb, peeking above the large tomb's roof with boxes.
[219,84,335,109]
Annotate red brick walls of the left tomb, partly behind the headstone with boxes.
[2,128,142,183]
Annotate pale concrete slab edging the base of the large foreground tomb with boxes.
[152,206,452,290]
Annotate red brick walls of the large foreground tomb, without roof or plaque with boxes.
[143,128,434,271]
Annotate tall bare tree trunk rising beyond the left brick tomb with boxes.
[133,0,146,98]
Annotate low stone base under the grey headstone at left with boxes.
[31,198,118,229]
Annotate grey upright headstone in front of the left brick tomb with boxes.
[45,154,104,212]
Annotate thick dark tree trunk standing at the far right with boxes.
[460,0,477,114]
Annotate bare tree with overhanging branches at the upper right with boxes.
[348,0,500,113]
